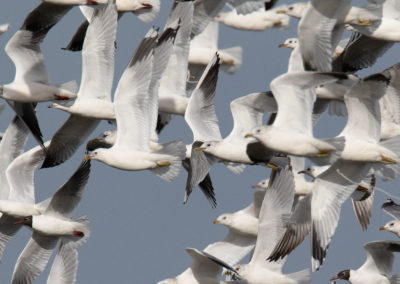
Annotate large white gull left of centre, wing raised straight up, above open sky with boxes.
[85,29,186,181]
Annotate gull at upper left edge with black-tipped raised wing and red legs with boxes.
[0,3,76,150]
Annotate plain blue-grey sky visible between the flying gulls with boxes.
[0,0,400,284]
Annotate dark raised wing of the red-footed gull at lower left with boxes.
[44,160,90,218]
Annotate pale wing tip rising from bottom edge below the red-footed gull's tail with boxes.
[47,242,78,284]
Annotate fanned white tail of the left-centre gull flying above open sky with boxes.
[151,140,186,181]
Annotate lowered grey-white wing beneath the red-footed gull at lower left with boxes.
[11,232,58,284]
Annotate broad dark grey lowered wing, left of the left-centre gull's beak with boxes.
[42,115,100,168]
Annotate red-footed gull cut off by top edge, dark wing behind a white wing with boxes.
[63,0,160,51]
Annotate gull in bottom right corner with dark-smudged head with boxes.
[330,241,400,284]
